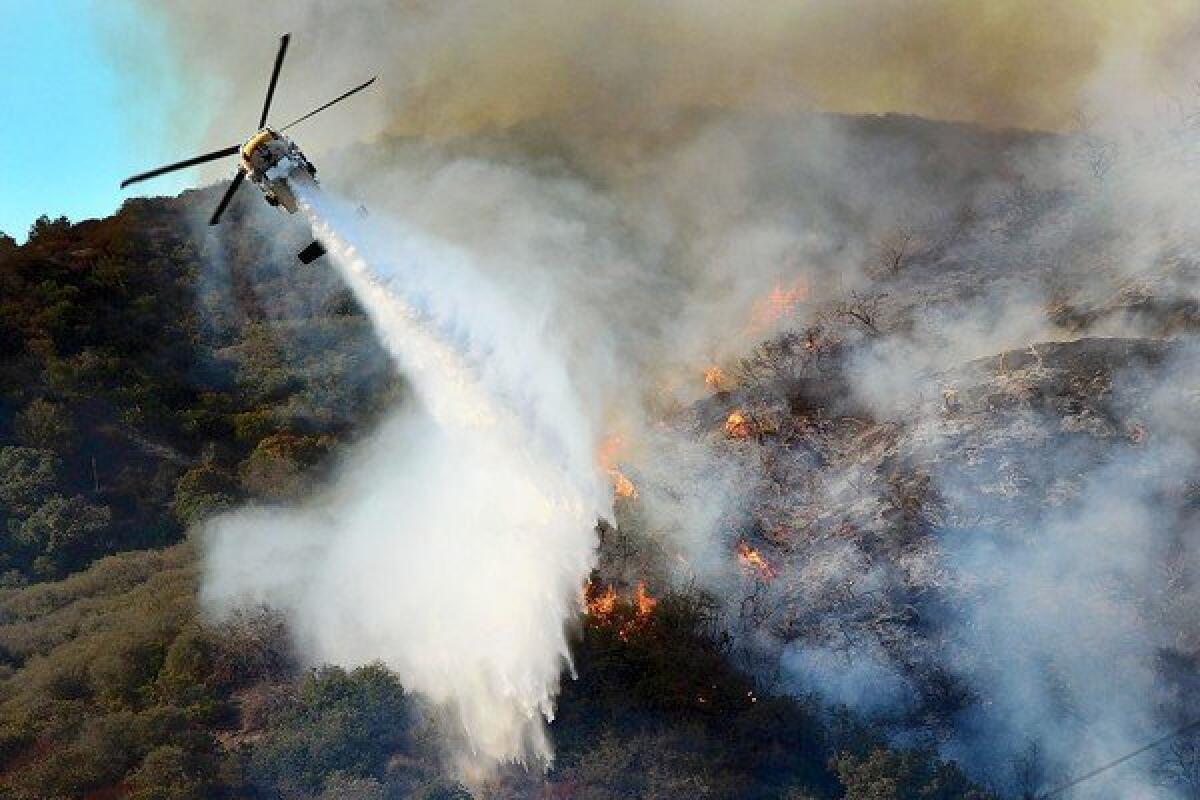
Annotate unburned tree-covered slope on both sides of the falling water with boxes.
[0,185,998,800]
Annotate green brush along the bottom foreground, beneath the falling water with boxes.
[0,545,985,800]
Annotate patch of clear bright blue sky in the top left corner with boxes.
[0,0,206,241]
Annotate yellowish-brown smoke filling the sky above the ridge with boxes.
[124,0,1200,148]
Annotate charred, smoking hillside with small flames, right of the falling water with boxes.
[590,239,1200,792]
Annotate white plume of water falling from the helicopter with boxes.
[204,184,610,769]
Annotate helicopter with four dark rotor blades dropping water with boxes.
[121,34,376,264]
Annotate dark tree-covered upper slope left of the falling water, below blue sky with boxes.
[0,193,396,585]
